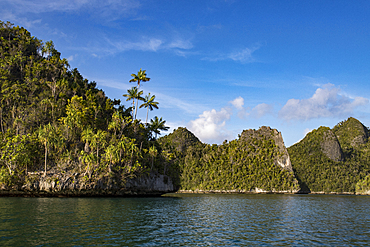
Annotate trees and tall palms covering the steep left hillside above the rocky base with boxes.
[0,21,168,186]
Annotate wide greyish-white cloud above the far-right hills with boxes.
[279,83,369,120]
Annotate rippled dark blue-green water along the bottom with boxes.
[0,194,370,246]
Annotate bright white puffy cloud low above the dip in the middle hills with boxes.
[188,108,232,143]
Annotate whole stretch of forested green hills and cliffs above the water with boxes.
[0,21,370,196]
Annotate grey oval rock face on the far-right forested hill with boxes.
[320,129,344,162]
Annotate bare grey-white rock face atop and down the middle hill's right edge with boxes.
[241,126,293,172]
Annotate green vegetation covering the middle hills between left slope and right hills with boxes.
[159,128,299,191]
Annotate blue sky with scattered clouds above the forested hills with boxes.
[0,0,370,146]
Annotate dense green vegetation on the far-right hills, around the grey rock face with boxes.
[288,118,370,192]
